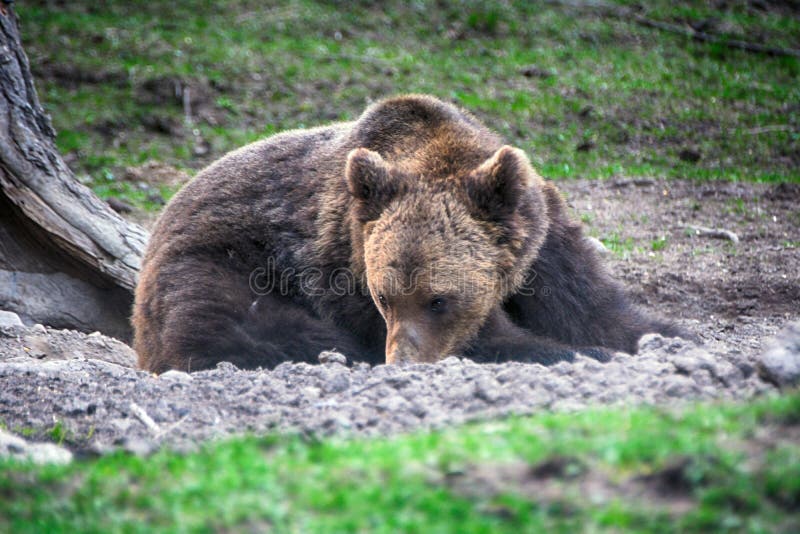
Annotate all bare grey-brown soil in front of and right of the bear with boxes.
[0,180,800,456]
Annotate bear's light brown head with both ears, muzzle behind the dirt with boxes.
[345,146,549,363]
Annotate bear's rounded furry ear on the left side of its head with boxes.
[345,148,398,221]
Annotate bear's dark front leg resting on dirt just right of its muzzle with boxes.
[464,308,611,365]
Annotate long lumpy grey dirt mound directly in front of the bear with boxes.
[0,327,774,453]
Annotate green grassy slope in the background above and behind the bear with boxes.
[18,0,800,214]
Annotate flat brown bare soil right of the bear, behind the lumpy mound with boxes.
[559,180,800,344]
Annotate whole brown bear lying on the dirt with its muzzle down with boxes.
[133,95,676,373]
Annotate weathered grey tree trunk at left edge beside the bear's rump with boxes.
[0,4,147,340]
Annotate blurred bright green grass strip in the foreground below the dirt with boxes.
[0,392,800,533]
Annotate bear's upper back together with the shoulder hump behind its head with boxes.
[148,95,502,276]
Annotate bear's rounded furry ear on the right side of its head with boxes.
[465,145,533,221]
